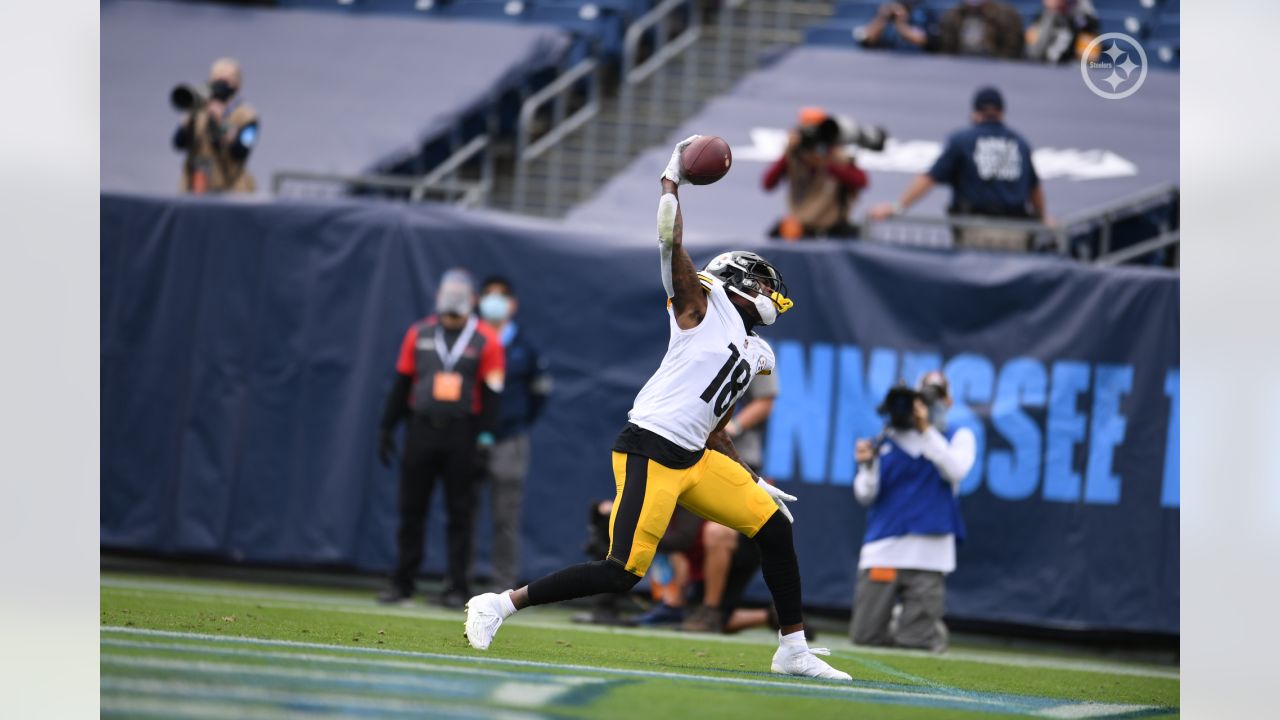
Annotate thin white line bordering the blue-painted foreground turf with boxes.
[102,626,1152,716]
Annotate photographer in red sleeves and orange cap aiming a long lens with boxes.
[764,108,884,241]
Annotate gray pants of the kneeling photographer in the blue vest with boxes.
[849,569,947,652]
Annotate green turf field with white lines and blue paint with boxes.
[101,573,1179,720]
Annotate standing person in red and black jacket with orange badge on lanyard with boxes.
[378,269,506,607]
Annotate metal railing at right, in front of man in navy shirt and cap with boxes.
[860,184,1179,264]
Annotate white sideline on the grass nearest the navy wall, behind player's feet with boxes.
[101,578,1180,680]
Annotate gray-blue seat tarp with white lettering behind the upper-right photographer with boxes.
[570,47,1179,242]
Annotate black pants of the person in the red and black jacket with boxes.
[392,415,475,594]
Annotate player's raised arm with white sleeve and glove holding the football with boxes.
[658,135,707,331]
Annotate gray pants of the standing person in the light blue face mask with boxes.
[488,433,529,589]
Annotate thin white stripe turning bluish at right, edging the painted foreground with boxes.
[102,626,1162,717]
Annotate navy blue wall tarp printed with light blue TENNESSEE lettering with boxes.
[100,193,1180,633]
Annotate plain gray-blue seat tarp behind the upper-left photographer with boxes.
[101,0,568,193]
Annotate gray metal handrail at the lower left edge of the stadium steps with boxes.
[512,58,600,211]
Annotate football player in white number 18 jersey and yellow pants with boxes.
[465,136,850,680]
